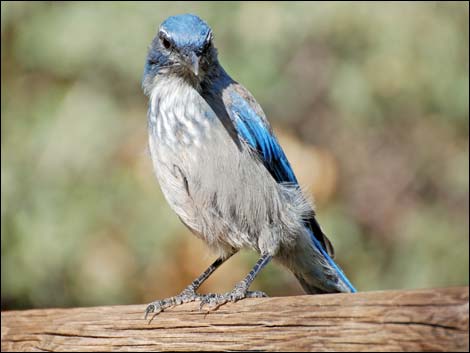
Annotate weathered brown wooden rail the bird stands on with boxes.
[1,287,469,351]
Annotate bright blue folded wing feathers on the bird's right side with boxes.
[230,92,298,184]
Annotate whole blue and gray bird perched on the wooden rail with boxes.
[142,14,356,317]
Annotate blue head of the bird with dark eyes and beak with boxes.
[142,14,217,93]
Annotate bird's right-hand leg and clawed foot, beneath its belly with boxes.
[200,254,272,309]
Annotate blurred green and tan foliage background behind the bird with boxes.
[1,2,469,309]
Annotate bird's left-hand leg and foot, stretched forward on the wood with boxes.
[145,254,232,319]
